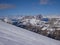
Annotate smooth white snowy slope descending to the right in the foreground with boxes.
[0,21,60,45]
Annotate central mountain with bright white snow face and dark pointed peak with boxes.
[20,15,42,26]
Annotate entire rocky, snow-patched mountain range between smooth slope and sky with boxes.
[0,15,60,40]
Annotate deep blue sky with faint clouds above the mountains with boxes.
[0,0,60,16]
